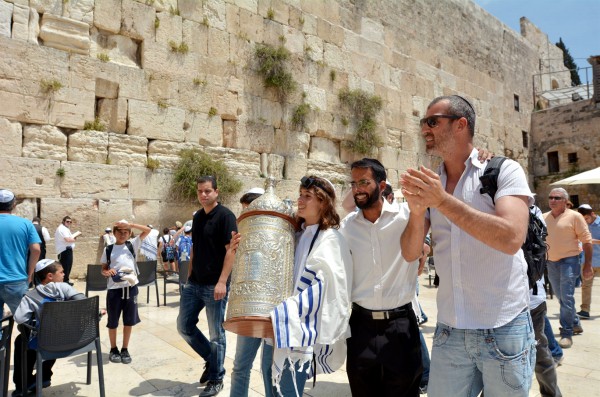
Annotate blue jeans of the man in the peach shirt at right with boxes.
[547,256,581,338]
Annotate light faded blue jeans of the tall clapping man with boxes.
[427,310,536,397]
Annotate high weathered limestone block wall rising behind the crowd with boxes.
[0,0,552,274]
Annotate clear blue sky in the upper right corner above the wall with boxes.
[474,0,600,83]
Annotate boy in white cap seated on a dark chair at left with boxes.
[12,259,85,397]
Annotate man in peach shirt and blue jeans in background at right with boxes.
[544,188,593,349]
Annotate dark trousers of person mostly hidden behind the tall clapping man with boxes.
[531,302,562,397]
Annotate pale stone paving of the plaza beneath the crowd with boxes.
[4,276,600,397]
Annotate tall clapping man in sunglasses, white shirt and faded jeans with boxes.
[401,95,536,397]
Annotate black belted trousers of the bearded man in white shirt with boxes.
[346,309,423,397]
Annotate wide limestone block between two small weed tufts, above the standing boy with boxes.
[60,161,129,199]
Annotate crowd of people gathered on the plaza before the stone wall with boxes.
[0,95,600,397]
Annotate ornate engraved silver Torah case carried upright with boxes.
[223,178,296,338]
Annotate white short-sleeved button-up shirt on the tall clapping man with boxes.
[430,150,533,329]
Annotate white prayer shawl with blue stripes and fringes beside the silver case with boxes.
[271,229,352,390]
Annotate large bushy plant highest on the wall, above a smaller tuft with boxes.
[254,44,297,99]
